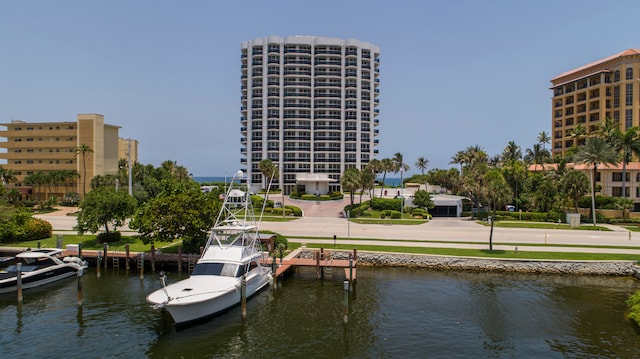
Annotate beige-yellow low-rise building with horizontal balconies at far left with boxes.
[0,114,138,200]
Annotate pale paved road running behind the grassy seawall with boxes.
[38,205,640,255]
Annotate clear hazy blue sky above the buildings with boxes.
[0,0,640,176]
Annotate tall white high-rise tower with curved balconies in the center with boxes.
[241,36,380,194]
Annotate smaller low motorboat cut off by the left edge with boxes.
[0,248,87,294]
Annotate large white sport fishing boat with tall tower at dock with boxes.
[147,171,271,325]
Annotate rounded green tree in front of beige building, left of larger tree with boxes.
[74,187,137,234]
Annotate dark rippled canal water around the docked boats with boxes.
[0,267,640,359]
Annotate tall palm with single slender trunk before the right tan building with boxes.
[575,137,618,226]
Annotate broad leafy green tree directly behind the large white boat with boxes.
[129,180,221,253]
